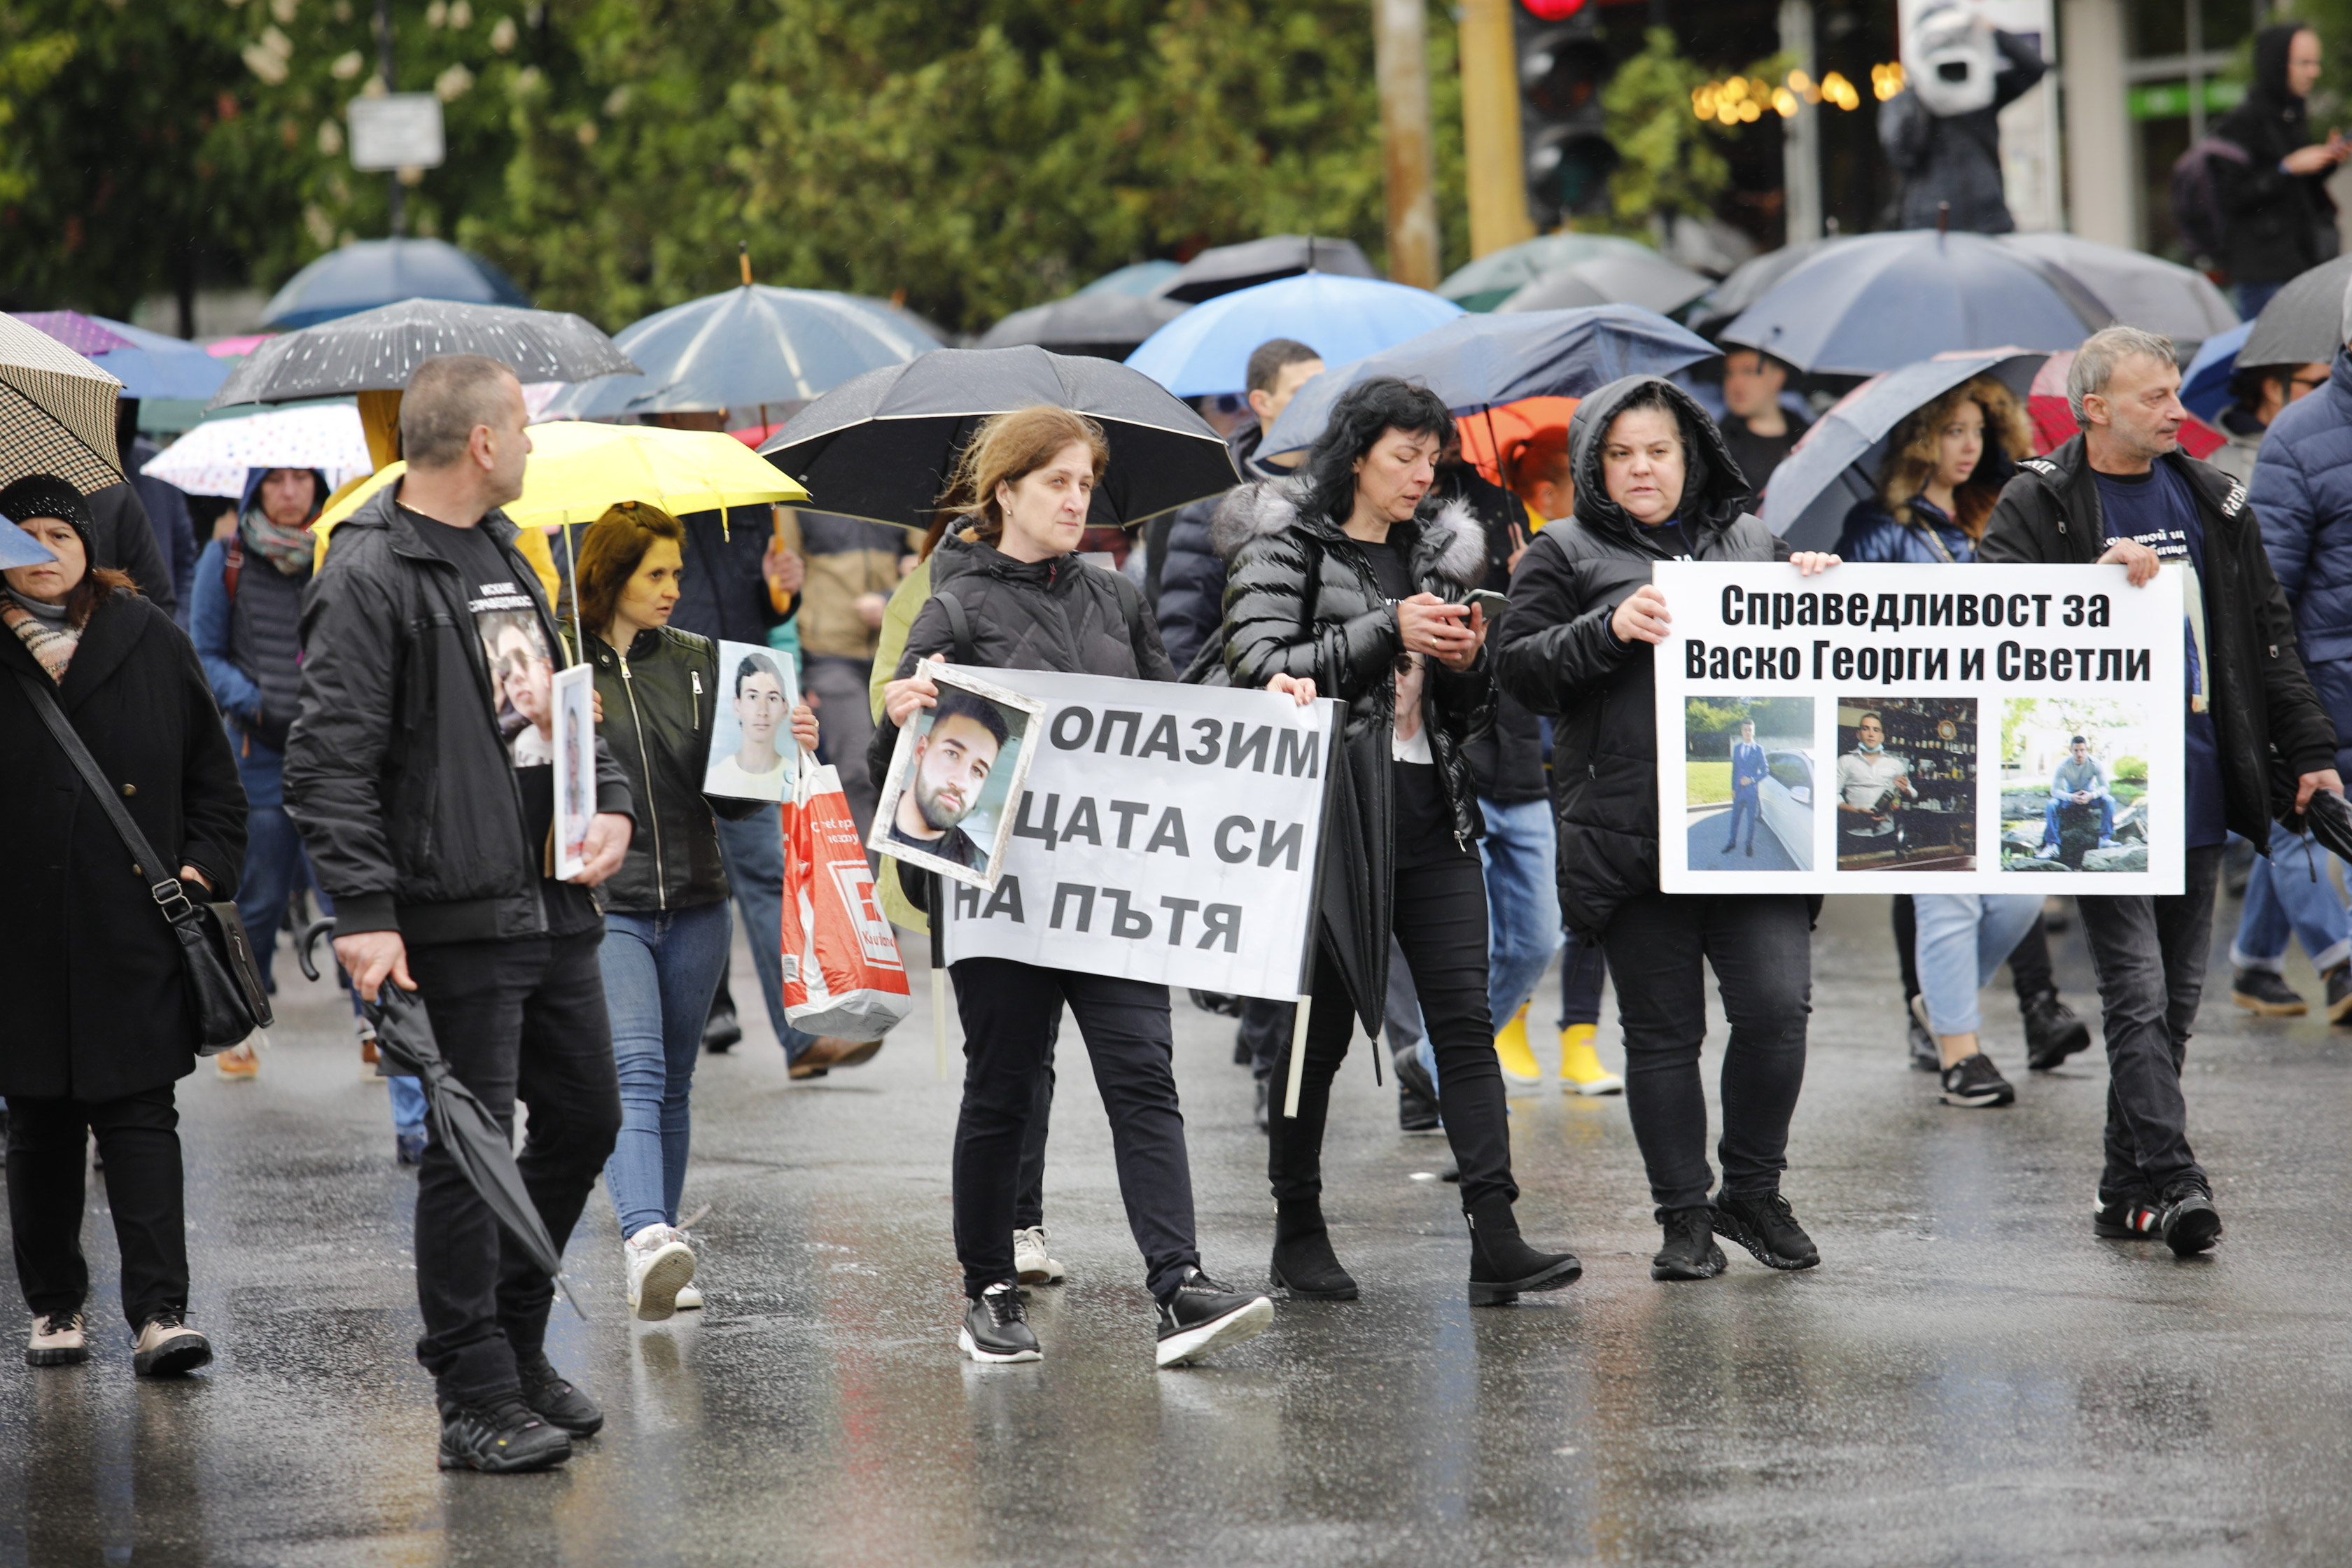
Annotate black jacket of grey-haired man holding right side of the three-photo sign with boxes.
[1975,430,2335,853]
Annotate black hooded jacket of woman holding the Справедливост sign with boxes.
[1496,376,1790,938]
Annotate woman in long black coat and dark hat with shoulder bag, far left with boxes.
[0,475,244,1376]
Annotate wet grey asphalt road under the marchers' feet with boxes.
[0,898,2352,1568]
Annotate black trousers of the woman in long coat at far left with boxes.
[7,1084,188,1331]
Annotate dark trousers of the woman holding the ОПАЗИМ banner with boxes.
[948,959,1200,1298]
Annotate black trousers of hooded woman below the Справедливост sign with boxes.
[1602,893,1814,1208]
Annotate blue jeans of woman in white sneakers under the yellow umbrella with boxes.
[597,900,734,1236]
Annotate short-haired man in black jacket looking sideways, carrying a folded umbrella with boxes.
[285,355,635,1471]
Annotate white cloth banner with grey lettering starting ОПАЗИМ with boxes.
[946,670,1340,1002]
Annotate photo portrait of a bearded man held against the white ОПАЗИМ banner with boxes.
[865,663,1040,888]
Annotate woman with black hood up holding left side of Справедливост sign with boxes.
[1496,376,1837,1279]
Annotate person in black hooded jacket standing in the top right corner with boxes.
[2213,21,2352,320]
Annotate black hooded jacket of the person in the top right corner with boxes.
[2213,21,2335,282]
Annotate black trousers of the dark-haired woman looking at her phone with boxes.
[1266,851,1520,1208]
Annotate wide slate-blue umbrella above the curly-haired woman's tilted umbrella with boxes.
[1722,228,2112,376]
